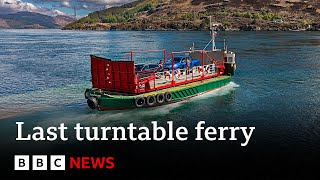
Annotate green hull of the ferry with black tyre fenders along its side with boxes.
[85,76,231,110]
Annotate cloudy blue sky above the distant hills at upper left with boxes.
[0,0,135,18]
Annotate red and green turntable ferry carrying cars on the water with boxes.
[84,23,236,110]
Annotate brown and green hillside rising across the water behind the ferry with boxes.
[64,0,320,30]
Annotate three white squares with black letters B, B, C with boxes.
[14,155,66,170]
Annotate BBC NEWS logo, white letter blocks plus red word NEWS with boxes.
[14,155,115,171]
